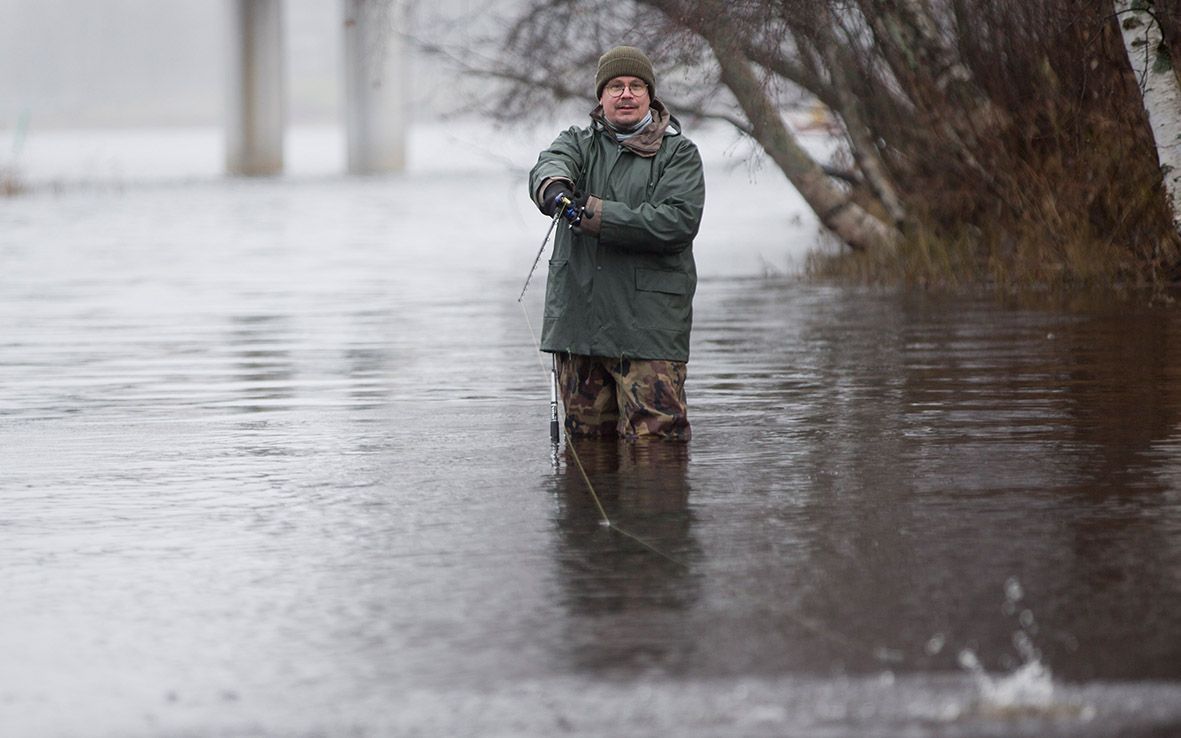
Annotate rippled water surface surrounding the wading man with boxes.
[0,171,1181,736]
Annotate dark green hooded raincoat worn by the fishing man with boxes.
[529,100,705,361]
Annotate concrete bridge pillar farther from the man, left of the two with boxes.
[226,0,286,176]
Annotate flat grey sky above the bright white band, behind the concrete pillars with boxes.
[0,0,498,129]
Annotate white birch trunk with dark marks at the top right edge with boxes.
[1115,0,1181,230]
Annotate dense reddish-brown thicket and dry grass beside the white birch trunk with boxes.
[811,0,1181,290]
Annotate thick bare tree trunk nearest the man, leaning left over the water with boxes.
[705,33,901,252]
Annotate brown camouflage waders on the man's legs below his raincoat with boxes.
[556,353,692,440]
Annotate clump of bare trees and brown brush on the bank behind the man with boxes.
[434,0,1181,281]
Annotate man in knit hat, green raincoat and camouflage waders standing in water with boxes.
[529,46,705,440]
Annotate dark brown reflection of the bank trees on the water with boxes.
[694,287,1181,679]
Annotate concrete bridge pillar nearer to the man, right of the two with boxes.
[342,0,409,175]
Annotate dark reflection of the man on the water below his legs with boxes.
[555,439,699,673]
